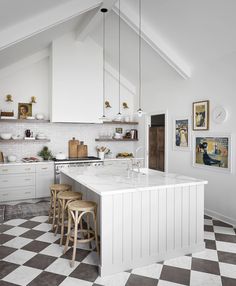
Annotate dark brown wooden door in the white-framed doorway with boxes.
[149,126,165,171]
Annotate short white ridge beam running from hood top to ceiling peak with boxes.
[76,0,117,41]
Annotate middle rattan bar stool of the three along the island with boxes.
[55,191,82,245]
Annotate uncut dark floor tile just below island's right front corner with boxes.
[191,258,220,275]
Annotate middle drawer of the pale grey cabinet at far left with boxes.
[0,174,35,189]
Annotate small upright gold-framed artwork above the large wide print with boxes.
[193,100,210,131]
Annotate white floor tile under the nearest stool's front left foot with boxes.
[45,258,79,276]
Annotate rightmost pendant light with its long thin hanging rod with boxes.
[137,0,143,117]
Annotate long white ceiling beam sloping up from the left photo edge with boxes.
[0,0,102,51]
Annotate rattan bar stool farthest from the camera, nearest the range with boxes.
[48,184,72,230]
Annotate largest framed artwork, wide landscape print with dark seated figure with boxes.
[193,133,232,172]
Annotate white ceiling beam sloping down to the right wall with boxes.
[113,1,191,79]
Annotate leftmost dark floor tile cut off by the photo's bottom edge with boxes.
[27,271,66,286]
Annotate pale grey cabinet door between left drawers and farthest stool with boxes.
[36,172,54,198]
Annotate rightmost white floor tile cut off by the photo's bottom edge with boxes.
[190,271,222,286]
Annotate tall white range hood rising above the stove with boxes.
[51,33,103,123]
